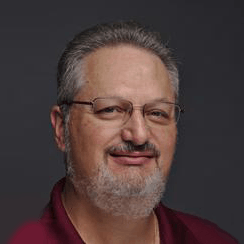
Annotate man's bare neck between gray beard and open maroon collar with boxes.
[62,180,157,244]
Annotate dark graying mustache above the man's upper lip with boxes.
[106,141,161,158]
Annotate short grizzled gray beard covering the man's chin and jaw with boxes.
[66,130,166,219]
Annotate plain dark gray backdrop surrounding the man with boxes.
[0,0,244,243]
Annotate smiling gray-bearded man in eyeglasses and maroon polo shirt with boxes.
[11,22,237,244]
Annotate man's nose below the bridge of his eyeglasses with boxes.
[121,109,149,145]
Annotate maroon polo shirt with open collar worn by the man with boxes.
[9,179,238,244]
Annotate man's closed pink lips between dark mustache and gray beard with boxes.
[110,152,154,166]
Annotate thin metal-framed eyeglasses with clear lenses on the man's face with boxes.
[59,97,184,126]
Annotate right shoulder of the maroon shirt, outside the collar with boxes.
[162,207,238,244]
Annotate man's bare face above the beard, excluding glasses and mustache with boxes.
[69,45,176,186]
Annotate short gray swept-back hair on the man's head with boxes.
[57,21,179,123]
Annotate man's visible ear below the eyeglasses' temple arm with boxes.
[50,105,65,152]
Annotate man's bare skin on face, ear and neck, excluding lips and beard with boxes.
[51,45,177,243]
